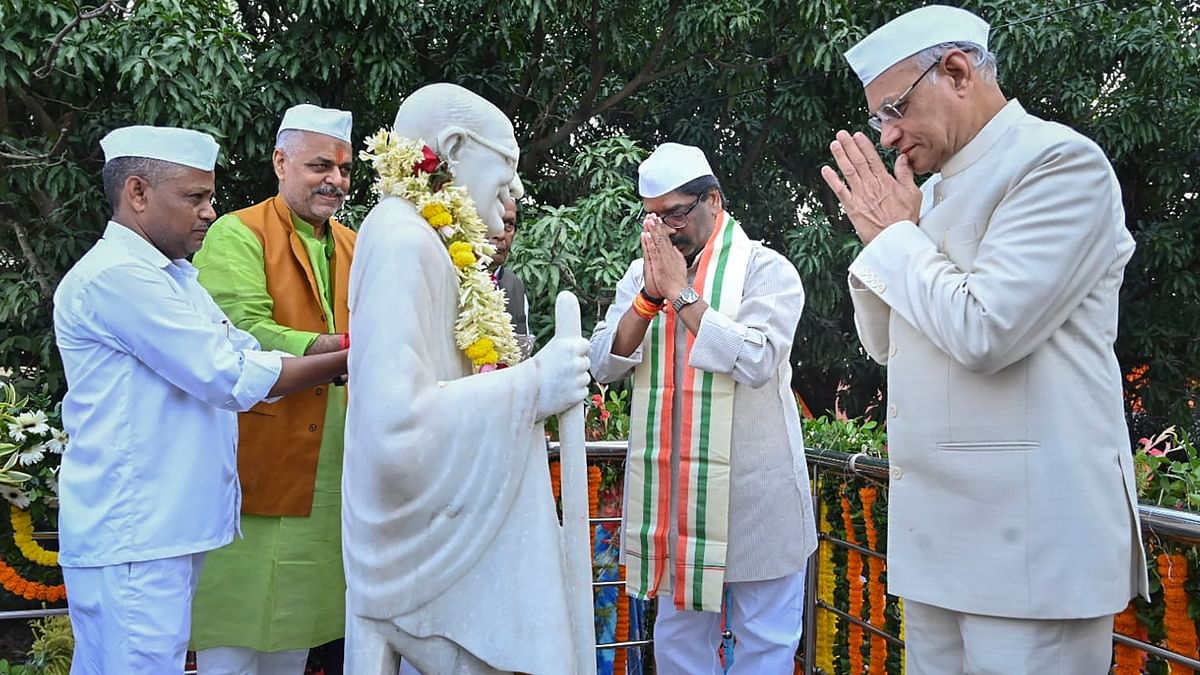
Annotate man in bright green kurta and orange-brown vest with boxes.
[192,103,355,675]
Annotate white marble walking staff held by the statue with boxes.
[554,291,596,675]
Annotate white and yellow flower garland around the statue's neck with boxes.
[359,129,521,372]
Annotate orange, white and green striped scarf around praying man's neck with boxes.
[623,213,751,611]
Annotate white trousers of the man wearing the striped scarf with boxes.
[654,571,804,675]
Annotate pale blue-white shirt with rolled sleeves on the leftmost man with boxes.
[54,222,281,567]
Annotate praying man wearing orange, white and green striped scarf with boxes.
[590,143,816,675]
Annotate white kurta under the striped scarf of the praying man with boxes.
[590,244,817,586]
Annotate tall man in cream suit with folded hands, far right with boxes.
[822,5,1147,675]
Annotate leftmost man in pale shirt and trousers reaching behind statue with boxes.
[54,126,346,675]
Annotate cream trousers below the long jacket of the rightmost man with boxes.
[904,599,1112,675]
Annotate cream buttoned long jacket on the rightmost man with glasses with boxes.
[850,101,1146,619]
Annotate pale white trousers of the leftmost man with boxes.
[62,554,204,675]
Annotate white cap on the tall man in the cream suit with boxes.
[846,5,991,86]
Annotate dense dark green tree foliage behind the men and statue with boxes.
[0,0,1200,418]
